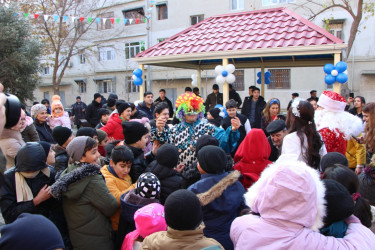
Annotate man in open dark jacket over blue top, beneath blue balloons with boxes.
[241,88,266,128]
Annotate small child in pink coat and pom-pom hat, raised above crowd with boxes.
[49,95,72,130]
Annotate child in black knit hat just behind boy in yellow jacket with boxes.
[122,121,150,183]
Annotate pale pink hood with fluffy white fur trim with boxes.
[245,154,326,231]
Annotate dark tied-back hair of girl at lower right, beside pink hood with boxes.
[323,164,372,227]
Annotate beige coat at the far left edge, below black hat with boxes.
[0,128,25,170]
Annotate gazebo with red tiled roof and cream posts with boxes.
[133,8,347,103]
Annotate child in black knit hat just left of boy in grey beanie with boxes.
[52,126,74,172]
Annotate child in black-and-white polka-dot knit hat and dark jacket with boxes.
[118,173,160,246]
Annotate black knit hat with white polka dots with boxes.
[135,172,160,199]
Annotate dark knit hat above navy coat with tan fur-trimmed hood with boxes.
[198,145,228,174]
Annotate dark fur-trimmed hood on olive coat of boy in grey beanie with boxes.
[50,163,101,199]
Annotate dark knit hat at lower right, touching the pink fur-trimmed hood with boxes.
[322,179,354,225]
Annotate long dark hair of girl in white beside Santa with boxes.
[286,101,323,169]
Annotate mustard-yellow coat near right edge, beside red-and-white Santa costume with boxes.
[346,138,366,168]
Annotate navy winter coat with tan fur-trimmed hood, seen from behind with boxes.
[188,171,246,250]
